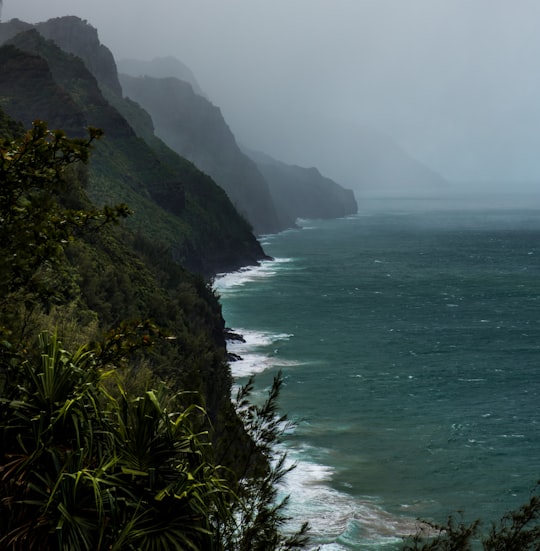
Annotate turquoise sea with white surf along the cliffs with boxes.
[216,206,540,551]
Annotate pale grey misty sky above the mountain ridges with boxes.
[2,0,540,189]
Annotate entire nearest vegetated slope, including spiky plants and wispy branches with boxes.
[0,118,305,550]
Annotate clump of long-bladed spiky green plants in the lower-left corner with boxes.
[0,333,229,550]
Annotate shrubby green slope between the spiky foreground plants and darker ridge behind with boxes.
[0,110,255,512]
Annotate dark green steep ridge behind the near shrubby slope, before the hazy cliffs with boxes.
[0,24,265,275]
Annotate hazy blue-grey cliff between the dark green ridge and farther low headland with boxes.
[120,75,281,234]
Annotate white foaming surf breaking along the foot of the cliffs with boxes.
[216,252,421,551]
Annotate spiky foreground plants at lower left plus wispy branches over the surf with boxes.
[0,325,307,551]
